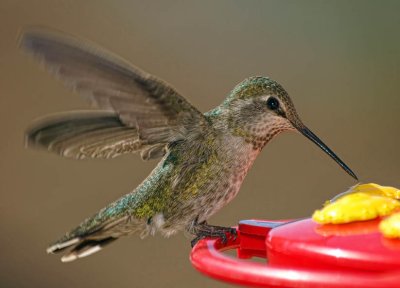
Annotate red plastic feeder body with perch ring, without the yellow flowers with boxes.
[190,218,400,288]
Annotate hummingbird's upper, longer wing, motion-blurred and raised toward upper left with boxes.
[20,29,207,158]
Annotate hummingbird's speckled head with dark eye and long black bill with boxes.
[223,76,357,180]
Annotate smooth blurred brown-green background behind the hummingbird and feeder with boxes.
[0,0,400,288]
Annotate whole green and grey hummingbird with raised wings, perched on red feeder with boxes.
[20,30,357,262]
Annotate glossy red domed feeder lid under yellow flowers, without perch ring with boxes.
[266,219,400,272]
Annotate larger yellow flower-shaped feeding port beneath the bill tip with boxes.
[312,183,400,224]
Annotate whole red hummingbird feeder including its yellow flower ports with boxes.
[190,183,400,288]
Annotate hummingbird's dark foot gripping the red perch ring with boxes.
[190,222,237,248]
